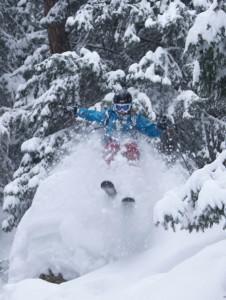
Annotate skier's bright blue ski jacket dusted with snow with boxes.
[76,108,161,139]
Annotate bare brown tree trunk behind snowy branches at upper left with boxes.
[44,0,70,54]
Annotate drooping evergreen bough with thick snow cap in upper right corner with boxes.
[185,0,226,102]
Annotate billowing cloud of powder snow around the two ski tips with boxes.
[9,134,183,281]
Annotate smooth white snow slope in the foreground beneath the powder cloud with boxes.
[0,228,226,300]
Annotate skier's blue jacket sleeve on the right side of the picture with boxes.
[136,115,162,137]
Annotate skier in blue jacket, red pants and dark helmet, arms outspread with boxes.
[73,90,167,163]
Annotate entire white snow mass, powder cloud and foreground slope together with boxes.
[0,136,226,300]
